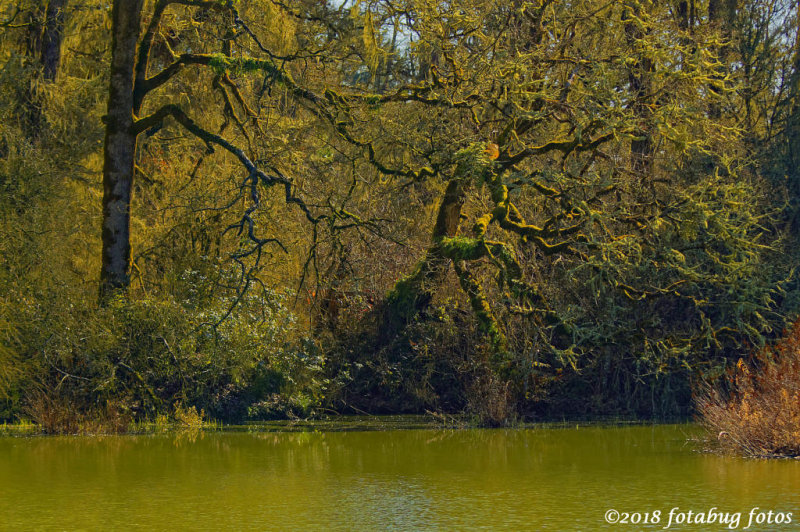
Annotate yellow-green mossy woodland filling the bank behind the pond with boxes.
[0,0,800,432]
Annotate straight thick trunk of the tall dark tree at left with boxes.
[100,0,144,301]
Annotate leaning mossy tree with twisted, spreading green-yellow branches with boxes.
[314,1,792,404]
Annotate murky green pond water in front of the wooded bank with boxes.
[0,425,800,530]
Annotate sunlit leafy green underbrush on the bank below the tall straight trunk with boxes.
[0,286,326,434]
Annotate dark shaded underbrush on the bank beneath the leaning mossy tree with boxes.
[327,298,704,427]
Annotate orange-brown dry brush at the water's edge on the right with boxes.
[696,320,800,457]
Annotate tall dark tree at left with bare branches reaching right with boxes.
[100,0,338,300]
